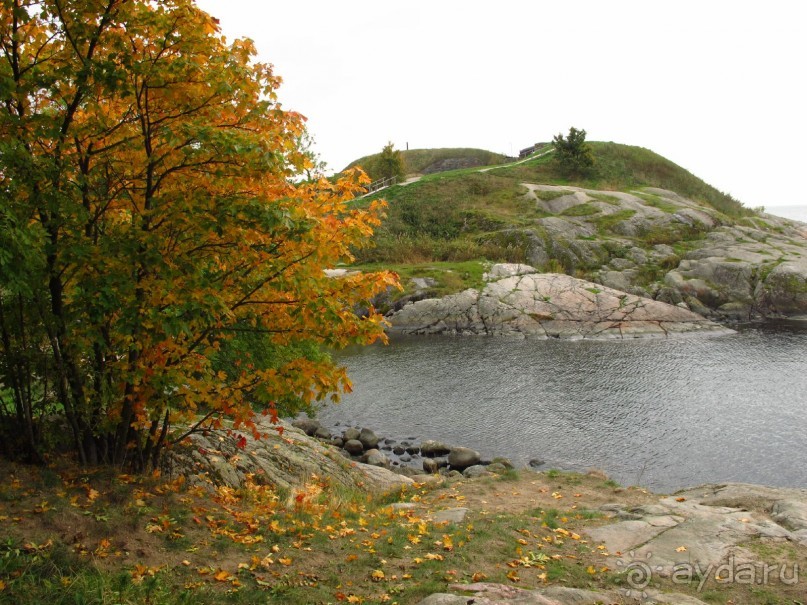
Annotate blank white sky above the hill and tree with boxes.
[197,0,807,207]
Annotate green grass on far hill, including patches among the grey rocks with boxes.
[353,143,753,272]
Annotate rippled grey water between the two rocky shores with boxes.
[319,324,807,491]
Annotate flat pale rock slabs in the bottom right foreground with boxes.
[418,484,807,605]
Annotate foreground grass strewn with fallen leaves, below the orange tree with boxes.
[0,466,632,605]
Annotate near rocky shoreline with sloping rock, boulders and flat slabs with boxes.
[161,418,807,605]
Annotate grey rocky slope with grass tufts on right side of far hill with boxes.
[516,183,807,319]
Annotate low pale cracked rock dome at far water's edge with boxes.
[389,264,727,338]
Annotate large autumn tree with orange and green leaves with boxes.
[0,0,395,468]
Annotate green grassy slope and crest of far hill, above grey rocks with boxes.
[354,143,750,264]
